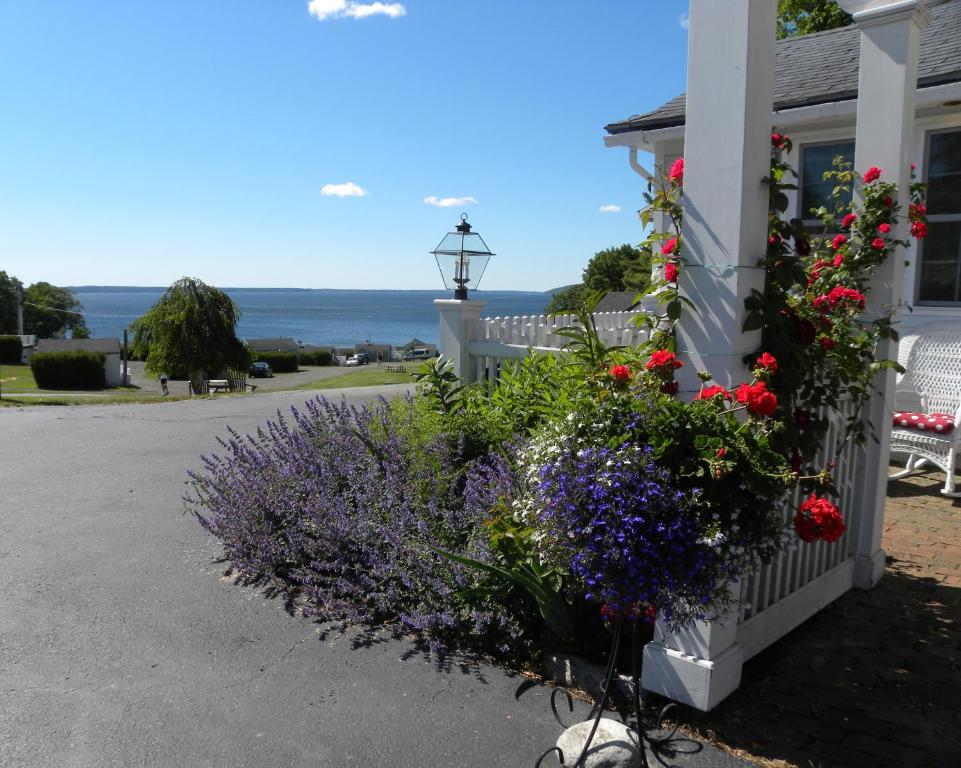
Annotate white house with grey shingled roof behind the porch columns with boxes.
[604,0,961,329]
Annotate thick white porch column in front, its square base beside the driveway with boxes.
[642,0,777,710]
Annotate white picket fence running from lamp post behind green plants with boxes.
[468,312,647,381]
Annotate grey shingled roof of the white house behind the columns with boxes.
[605,0,961,134]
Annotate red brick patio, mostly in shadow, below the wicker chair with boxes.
[693,464,961,768]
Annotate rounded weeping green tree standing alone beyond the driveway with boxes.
[132,277,250,380]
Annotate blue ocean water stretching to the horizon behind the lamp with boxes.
[70,286,550,346]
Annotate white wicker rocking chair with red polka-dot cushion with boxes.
[889,322,961,497]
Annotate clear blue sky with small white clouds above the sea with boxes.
[0,0,687,290]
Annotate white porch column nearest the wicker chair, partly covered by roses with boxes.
[841,0,927,589]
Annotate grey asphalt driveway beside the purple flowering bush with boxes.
[0,387,743,768]
